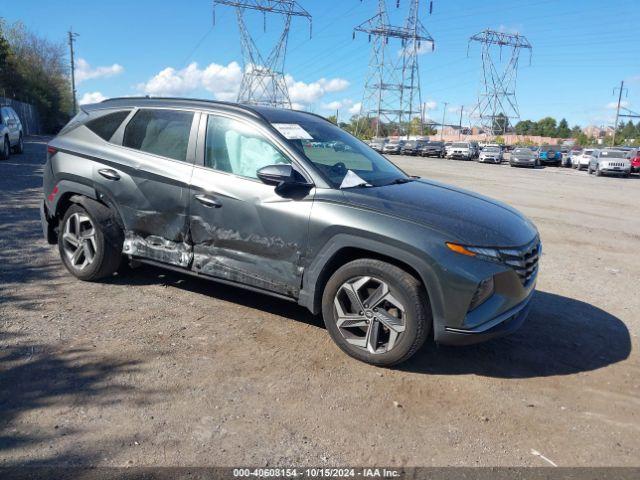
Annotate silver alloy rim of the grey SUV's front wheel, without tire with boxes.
[333,276,405,354]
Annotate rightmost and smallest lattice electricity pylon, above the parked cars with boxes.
[469,30,532,136]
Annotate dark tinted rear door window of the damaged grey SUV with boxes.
[122,110,193,161]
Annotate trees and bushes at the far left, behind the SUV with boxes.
[0,19,72,133]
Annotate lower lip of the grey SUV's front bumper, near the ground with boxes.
[438,289,535,345]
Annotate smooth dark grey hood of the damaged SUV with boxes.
[343,179,537,247]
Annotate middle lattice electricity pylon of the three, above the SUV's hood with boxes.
[353,0,434,136]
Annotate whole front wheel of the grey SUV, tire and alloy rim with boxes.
[322,259,432,367]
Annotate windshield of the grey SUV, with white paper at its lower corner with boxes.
[276,117,410,188]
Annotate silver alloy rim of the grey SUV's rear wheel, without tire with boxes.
[62,213,98,270]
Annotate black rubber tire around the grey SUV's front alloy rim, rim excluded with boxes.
[322,258,432,367]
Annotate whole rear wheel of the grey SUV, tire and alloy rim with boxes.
[58,202,124,281]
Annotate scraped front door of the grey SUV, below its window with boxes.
[190,166,313,298]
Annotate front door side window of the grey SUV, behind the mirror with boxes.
[204,116,290,178]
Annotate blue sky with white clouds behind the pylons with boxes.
[6,0,640,125]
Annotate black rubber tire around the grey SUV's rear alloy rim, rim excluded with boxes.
[58,199,124,282]
